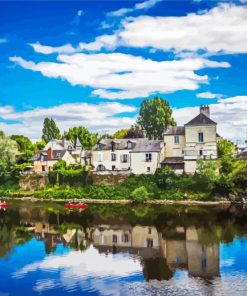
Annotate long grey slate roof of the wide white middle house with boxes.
[93,138,163,152]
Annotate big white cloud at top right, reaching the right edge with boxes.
[119,4,247,53]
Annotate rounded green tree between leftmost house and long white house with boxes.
[64,126,99,150]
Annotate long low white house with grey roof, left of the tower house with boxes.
[92,138,164,174]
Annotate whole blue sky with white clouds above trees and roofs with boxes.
[0,0,247,142]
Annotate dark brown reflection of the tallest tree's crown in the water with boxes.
[142,258,173,281]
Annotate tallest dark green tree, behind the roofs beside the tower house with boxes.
[137,97,176,140]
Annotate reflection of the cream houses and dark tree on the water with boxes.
[93,225,219,280]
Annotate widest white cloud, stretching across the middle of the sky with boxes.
[10,53,230,99]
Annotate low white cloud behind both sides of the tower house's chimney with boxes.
[174,95,247,143]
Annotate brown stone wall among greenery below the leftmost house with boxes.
[19,174,49,192]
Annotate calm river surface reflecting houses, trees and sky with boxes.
[0,201,247,296]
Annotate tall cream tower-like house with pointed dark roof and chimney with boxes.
[162,106,219,174]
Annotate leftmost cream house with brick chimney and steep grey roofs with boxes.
[32,140,76,173]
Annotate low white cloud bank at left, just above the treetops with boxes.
[0,102,136,140]
